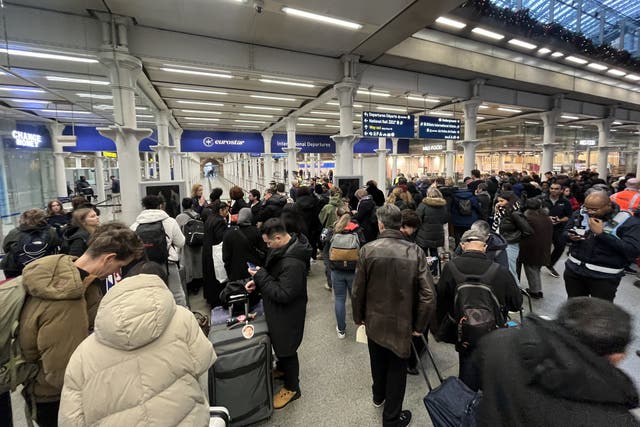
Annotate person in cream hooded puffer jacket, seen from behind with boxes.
[58,274,216,427]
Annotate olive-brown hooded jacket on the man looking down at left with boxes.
[18,255,100,402]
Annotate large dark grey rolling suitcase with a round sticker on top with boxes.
[209,295,273,426]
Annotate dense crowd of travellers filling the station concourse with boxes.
[0,170,640,426]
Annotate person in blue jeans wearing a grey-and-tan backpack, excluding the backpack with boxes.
[327,213,365,339]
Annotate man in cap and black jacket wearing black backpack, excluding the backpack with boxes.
[437,229,522,390]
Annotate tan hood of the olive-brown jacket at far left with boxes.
[22,255,96,301]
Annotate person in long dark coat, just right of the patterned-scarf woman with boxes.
[518,199,553,298]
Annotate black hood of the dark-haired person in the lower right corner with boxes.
[516,315,638,408]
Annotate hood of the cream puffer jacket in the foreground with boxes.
[95,274,176,351]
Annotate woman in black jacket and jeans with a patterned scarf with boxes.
[491,191,533,284]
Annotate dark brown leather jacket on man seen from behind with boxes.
[351,230,436,359]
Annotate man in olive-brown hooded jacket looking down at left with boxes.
[18,224,144,427]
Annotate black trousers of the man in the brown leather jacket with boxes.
[368,338,407,427]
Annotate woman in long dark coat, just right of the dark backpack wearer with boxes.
[202,200,229,308]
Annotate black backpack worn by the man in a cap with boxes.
[447,262,506,351]
